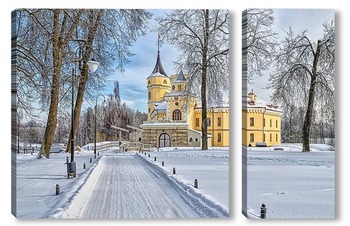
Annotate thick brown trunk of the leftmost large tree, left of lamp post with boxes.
[40,9,62,158]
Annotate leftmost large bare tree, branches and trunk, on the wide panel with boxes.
[17,9,82,158]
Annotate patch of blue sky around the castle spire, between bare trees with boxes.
[103,10,177,112]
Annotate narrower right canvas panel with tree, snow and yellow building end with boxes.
[242,9,335,219]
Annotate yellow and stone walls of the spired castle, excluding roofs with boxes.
[143,71,229,147]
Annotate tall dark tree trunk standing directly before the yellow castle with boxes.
[201,9,209,150]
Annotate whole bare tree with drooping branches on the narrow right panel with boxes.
[269,21,335,152]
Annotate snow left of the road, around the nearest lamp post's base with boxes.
[15,152,102,219]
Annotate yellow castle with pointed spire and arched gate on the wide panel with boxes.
[140,47,229,147]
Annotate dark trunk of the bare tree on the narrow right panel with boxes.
[303,40,321,152]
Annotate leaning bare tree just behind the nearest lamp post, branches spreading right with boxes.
[68,9,151,154]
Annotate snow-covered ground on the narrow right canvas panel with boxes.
[243,144,335,219]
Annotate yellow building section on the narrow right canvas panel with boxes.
[242,91,282,146]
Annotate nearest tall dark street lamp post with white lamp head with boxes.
[67,48,99,178]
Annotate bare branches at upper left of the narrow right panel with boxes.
[242,9,277,82]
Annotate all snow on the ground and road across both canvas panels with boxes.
[11,144,335,219]
